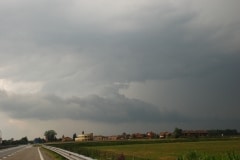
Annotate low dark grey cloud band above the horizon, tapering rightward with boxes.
[0,91,188,123]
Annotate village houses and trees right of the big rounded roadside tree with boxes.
[59,128,240,142]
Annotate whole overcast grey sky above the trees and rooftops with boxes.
[0,0,240,139]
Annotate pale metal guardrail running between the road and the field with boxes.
[42,145,94,160]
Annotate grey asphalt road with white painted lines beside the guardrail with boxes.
[0,145,52,160]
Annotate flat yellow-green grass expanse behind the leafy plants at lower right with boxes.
[89,139,240,160]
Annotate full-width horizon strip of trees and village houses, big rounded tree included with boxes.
[0,128,240,148]
